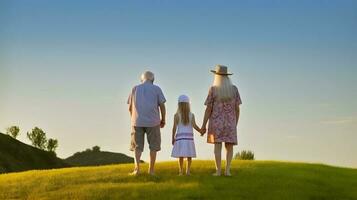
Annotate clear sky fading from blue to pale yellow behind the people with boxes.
[0,0,357,167]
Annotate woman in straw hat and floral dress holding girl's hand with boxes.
[201,65,242,176]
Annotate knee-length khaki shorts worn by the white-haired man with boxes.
[130,126,161,152]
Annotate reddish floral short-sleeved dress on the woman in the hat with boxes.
[205,86,242,145]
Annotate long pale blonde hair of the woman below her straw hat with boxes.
[213,74,234,101]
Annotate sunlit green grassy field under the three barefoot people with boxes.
[0,160,357,200]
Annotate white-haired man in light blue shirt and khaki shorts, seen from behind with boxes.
[128,71,166,175]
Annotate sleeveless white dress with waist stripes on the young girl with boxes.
[171,113,196,158]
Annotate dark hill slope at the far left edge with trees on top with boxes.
[0,133,69,173]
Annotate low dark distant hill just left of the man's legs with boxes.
[65,150,138,166]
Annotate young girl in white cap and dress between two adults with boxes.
[171,95,201,175]
